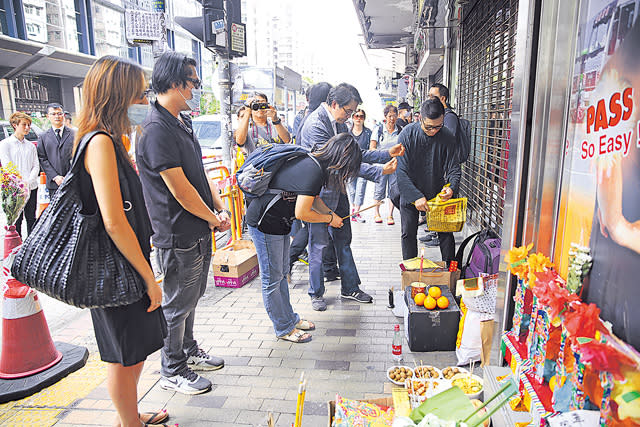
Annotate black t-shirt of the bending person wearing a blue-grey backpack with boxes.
[246,156,328,235]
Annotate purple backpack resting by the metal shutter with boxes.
[455,228,502,279]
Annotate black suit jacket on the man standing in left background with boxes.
[38,126,75,190]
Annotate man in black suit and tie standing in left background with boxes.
[37,104,75,196]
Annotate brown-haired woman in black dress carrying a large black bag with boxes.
[74,56,168,427]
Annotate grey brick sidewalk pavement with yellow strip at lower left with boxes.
[0,212,459,427]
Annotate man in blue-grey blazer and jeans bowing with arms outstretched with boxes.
[300,83,404,311]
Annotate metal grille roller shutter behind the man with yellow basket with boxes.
[457,0,518,234]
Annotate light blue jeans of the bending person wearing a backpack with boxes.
[249,226,300,337]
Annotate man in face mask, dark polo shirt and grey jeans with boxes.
[136,51,229,394]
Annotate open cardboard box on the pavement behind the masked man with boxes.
[211,240,260,288]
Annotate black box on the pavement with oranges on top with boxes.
[404,285,460,351]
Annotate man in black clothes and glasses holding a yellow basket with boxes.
[396,98,462,262]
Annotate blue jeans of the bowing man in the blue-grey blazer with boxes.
[309,195,360,297]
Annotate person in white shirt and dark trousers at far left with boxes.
[0,112,40,236]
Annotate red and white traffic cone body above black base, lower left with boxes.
[0,279,62,378]
